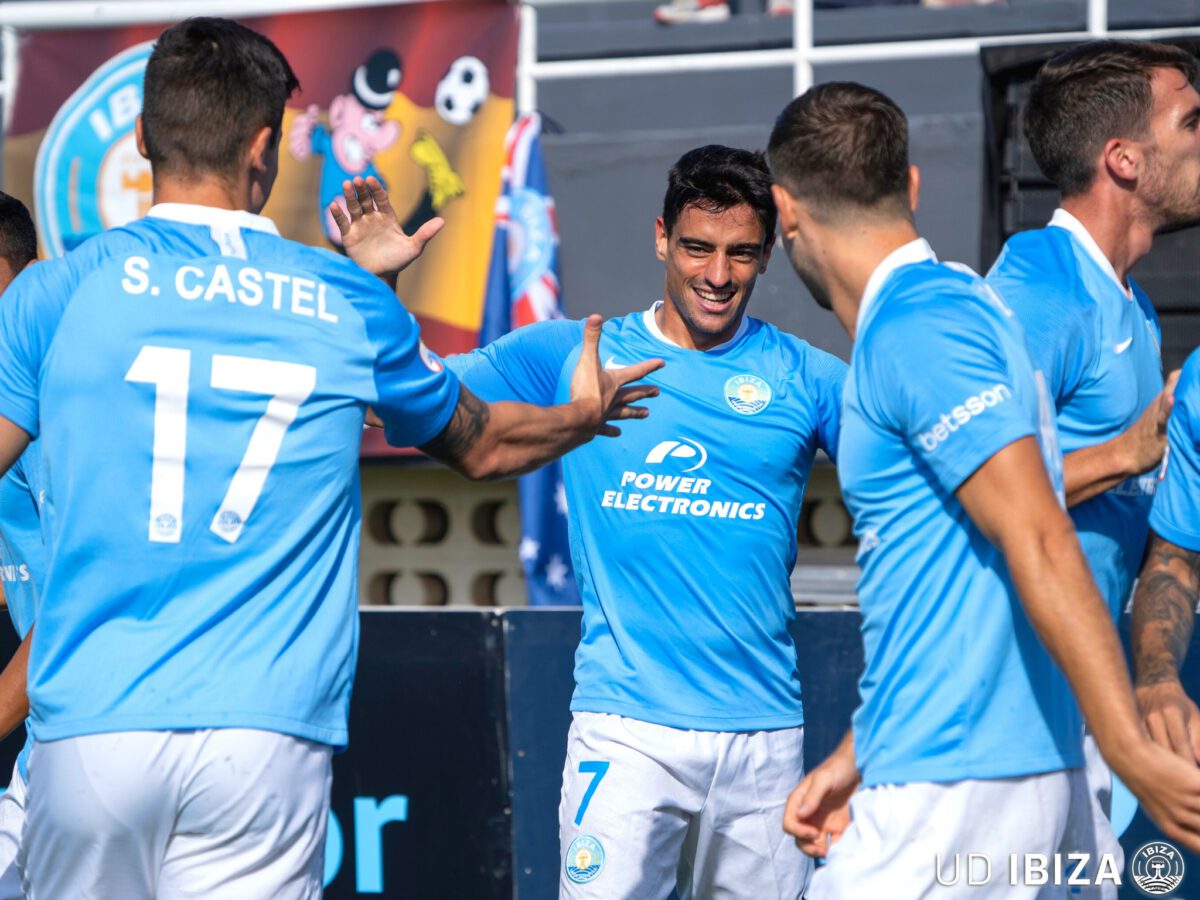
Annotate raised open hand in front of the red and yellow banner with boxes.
[329,175,445,280]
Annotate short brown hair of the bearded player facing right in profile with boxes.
[1025,41,1196,197]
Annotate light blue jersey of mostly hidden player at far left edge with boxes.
[0,443,48,779]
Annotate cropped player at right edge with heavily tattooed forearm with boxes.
[1133,350,1200,764]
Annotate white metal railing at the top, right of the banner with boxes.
[516,0,1200,113]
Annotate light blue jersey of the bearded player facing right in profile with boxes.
[988,210,1163,618]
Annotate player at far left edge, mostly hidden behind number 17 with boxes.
[0,192,38,900]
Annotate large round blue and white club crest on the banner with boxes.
[34,41,154,256]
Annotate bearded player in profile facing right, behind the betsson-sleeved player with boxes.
[988,41,1200,896]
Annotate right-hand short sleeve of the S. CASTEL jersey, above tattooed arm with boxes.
[359,280,458,446]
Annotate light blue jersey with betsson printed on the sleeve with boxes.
[838,241,1082,786]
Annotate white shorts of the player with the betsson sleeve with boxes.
[806,769,1104,900]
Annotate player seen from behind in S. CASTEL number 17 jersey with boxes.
[0,18,658,900]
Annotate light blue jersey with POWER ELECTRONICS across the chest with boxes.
[449,310,846,731]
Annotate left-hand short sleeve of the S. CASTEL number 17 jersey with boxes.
[0,259,74,438]
